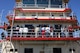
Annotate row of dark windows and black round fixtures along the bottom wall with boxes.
[10,48,75,53]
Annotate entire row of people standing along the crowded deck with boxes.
[2,25,80,37]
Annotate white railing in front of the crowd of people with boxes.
[7,29,80,38]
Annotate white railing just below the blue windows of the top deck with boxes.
[16,3,67,8]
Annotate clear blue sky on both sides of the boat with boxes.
[0,0,80,36]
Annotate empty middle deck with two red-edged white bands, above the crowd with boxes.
[7,8,77,25]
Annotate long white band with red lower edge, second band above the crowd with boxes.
[15,16,76,20]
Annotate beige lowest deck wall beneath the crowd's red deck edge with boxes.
[3,41,80,53]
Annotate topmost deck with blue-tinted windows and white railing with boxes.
[16,0,69,9]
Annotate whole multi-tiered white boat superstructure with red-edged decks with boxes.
[0,0,80,53]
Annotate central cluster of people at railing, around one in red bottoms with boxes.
[35,26,53,37]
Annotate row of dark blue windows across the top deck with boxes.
[23,0,62,5]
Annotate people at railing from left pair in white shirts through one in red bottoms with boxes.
[16,26,53,37]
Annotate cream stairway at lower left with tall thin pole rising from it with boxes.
[2,9,15,53]
